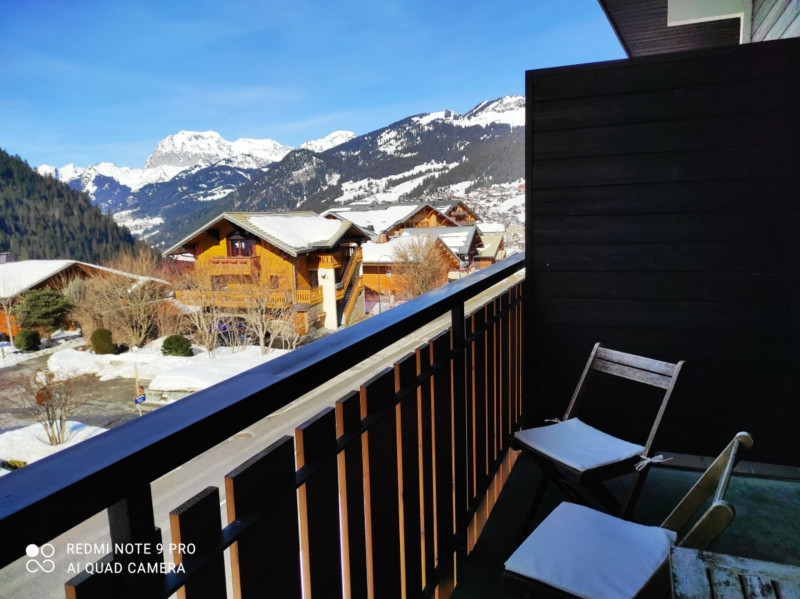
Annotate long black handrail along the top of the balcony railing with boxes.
[0,254,525,567]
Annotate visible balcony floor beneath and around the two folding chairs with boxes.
[453,454,800,599]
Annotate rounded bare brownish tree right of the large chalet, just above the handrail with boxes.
[392,235,449,299]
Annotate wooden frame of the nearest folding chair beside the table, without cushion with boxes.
[502,432,753,599]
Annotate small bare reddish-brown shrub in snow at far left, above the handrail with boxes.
[6,368,92,445]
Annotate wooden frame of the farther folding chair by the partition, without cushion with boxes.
[514,343,684,519]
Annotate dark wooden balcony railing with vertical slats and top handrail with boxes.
[0,255,524,599]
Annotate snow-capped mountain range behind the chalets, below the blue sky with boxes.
[37,96,525,246]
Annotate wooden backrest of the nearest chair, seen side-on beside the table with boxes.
[661,432,753,549]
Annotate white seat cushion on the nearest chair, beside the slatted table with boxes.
[506,502,677,599]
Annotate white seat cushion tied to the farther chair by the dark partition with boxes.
[515,418,644,471]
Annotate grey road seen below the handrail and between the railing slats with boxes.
[0,276,521,599]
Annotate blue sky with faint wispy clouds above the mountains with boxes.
[0,0,624,167]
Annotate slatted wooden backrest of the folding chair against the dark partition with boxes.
[564,343,684,456]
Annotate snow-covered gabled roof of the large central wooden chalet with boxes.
[164,211,367,256]
